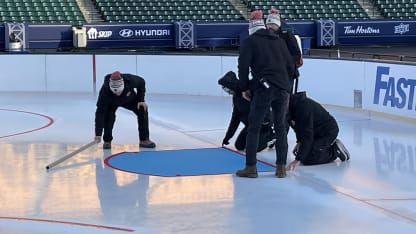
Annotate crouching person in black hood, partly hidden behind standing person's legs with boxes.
[218,71,274,152]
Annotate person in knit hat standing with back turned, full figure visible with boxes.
[236,10,294,178]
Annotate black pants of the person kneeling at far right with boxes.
[301,124,339,165]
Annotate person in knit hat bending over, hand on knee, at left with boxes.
[95,71,156,149]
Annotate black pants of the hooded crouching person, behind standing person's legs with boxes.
[234,123,274,152]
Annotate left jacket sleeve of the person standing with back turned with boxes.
[238,39,252,91]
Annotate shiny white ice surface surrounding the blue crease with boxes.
[0,93,416,234]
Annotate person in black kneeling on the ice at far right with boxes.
[287,92,350,170]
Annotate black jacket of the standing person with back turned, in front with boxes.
[238,29,294,93]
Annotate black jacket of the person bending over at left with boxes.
[95,73,146,136]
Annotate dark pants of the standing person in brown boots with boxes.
[246,86,289,166]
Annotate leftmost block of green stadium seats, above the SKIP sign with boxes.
[0,0,85,25]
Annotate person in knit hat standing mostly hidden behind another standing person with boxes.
[266,7,303,92]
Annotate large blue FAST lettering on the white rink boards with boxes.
[373,66,416,110]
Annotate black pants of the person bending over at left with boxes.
[103,102,149,142]
